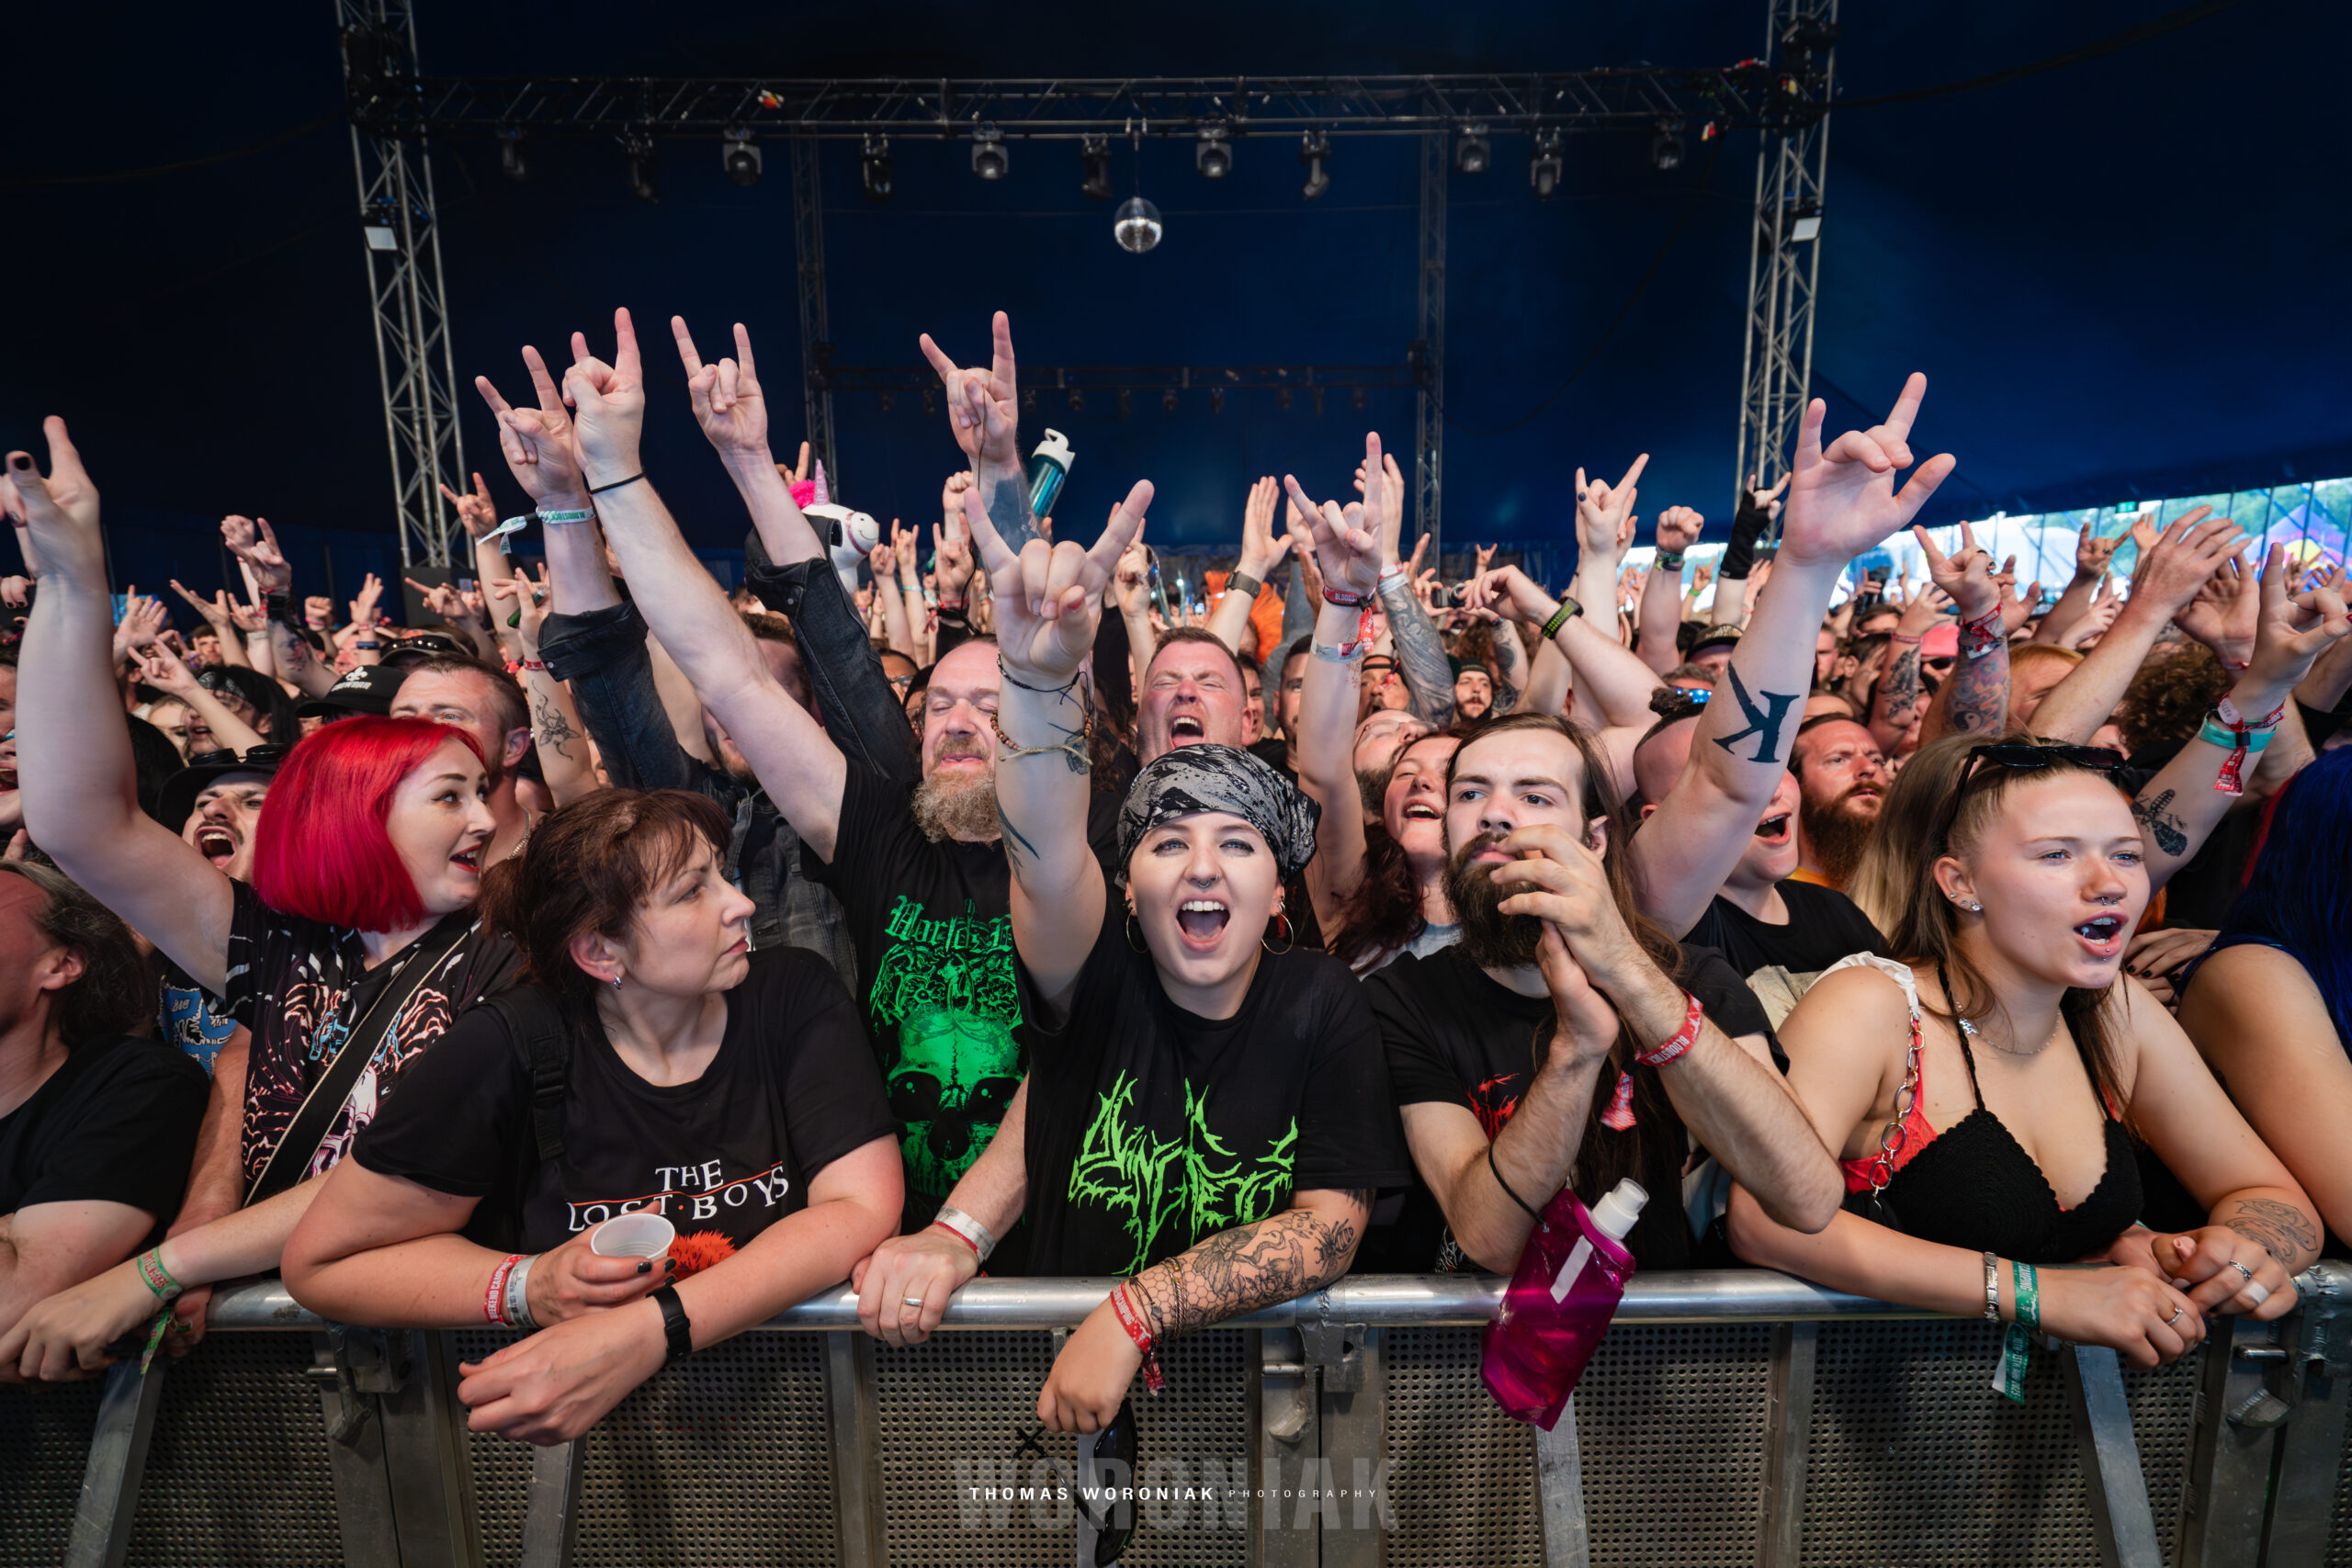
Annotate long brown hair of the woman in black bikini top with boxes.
[1865,731,2131,1126]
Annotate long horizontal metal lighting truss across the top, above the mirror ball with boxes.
[345,70,1834,141]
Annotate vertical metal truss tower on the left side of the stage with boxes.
[334,0,466,567]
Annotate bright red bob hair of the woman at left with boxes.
[254,717,482,931]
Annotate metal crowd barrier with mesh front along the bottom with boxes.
[0,1265,2352,1568]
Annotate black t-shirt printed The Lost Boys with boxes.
[350,947,899,1256]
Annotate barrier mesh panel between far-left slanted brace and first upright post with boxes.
[125,1333,344,1568]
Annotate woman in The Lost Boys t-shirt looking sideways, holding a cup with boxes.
[285,790,900,1443]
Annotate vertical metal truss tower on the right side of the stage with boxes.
[1731,0,1837,522]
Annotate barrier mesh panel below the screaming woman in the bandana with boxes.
[875,1328,1256,1568]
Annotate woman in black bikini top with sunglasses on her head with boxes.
[1731,736,2319,1375]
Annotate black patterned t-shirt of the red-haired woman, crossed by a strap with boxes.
[228,882,520,1182]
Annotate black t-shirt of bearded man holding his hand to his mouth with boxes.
[1364,945,1769,1269]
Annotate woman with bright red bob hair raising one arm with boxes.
[0,419,515,1375]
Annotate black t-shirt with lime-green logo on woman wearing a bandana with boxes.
[1021,898,1414,1277]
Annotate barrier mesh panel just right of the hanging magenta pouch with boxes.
[1576,1324,1771,1568]
